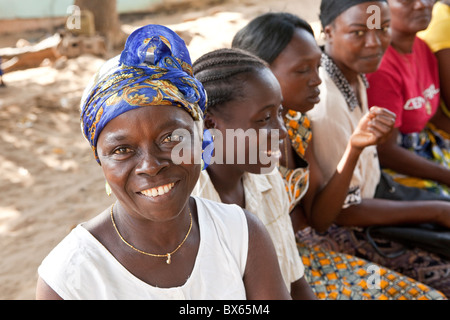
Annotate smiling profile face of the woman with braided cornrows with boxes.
[205,68,287,174]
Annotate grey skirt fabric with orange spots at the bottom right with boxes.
[297,228,446,300]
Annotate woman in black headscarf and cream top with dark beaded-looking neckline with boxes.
[308,0,450,295]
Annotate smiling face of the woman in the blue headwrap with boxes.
[97,106,201,221]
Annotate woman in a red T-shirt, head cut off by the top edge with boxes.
[367,0,450,200]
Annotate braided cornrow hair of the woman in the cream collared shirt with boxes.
[193,48,269,112]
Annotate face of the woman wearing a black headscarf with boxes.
[324,1,391,75]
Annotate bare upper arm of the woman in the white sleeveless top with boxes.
[244,210,291,300]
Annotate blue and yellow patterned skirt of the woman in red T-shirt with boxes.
[384,123,450,197]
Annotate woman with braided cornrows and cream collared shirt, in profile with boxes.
[193,49,315,299]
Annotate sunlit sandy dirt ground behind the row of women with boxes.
[0,0,320,300]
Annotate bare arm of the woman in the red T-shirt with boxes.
[378,129,450,187]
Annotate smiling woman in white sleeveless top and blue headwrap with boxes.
[36,25,290,299]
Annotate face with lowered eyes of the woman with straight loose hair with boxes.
[270,28,322,112]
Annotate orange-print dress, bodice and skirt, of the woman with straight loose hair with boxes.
[279,110,446,300]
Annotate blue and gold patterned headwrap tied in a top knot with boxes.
[80,25,206,163]
